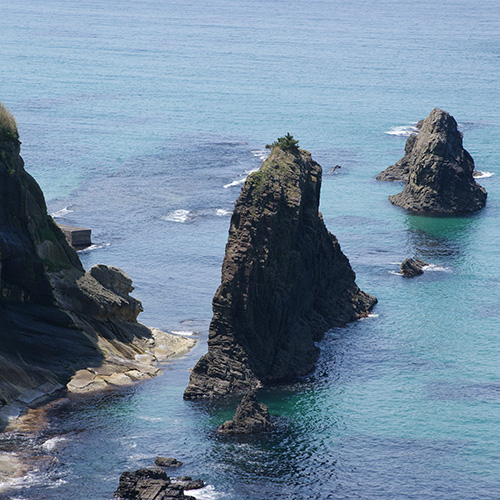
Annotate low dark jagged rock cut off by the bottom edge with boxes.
[115,469,196,500]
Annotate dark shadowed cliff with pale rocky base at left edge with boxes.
[0,104,192,418]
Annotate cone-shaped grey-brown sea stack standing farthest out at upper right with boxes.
[382,108,486,215]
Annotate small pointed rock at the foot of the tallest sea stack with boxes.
[219,390,274,434]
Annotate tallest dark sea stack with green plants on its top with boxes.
[184,146,376,399]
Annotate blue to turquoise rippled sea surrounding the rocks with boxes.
[0,0,500,500]
